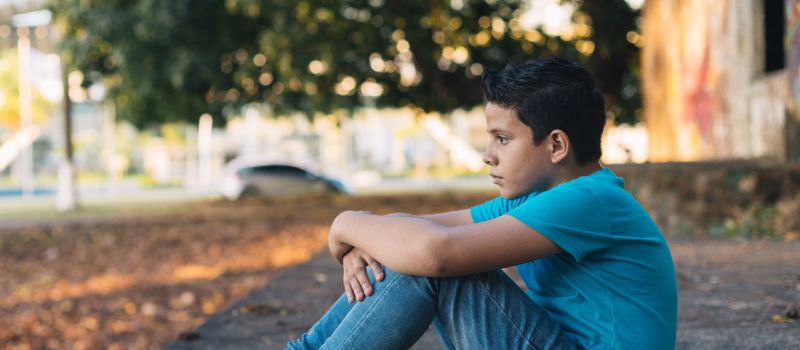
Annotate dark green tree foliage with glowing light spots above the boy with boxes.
[52,0,638,126]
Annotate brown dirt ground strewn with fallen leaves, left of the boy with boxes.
[0,193,493,350]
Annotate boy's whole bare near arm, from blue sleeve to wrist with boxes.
[329,212,564,277]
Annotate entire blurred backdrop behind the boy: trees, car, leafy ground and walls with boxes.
[0,0,800,349]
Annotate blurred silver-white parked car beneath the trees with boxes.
[222,157,353,200]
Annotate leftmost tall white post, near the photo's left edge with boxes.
[17,27,34,200]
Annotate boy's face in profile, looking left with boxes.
[483,103,555,200]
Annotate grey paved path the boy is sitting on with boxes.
[165,239,800,350]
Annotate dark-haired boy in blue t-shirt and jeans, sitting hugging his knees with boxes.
[289,58,678,350]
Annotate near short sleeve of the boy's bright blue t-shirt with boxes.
[510,181,616,261]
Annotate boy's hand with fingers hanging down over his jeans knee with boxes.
[342,248,384,303]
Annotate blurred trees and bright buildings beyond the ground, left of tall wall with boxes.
[0,0,648,209]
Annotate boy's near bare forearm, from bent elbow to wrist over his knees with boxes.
[331,212,447,275]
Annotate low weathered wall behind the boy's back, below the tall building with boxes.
[611,161,800,239]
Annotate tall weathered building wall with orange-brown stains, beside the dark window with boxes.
[642,0,797,162]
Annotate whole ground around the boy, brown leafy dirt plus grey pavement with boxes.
[0,192,800,349]
